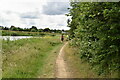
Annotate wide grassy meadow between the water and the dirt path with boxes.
[2,36,62,78]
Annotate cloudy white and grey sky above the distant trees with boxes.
[0,0,70,30]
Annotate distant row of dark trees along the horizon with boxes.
[0,26,64,33]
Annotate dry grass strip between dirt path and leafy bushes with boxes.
[64,42,118,78]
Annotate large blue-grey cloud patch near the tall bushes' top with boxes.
[43,2,69,15]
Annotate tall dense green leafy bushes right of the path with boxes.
[69,2,120,75]
